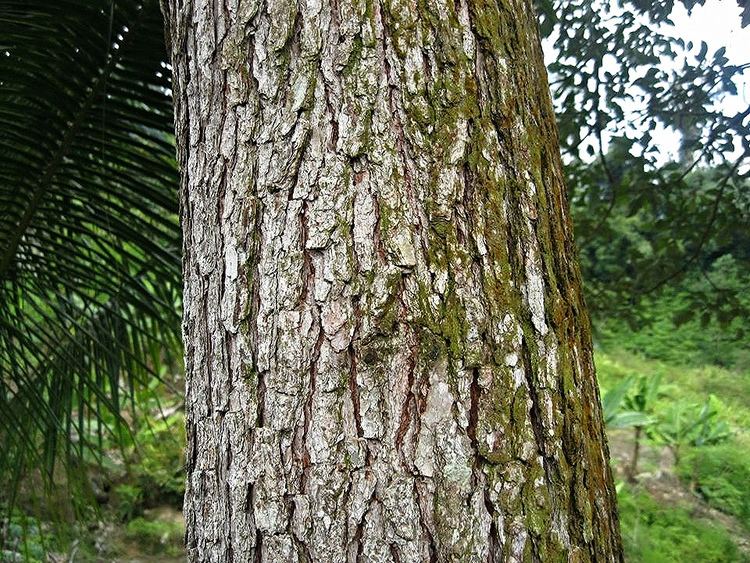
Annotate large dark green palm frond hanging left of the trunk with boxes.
[0,0,181,501]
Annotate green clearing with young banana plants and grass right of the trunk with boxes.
[596,340,750,563]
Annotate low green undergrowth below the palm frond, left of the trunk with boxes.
[0,396,185,561]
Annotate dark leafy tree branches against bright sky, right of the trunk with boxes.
[537,0,750,322]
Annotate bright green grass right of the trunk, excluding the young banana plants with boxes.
[595,348,750,563]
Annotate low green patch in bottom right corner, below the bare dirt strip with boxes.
[618,486,749,563]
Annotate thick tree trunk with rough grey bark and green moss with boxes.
[164,0,621,562]
